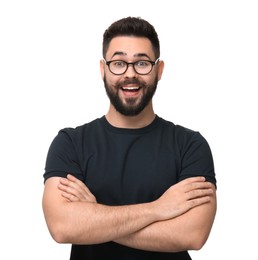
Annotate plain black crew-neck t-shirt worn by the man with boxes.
[44,116,216,260]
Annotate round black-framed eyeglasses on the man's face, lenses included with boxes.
[104,58,159,75]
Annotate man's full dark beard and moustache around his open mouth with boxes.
[104,76,158,116]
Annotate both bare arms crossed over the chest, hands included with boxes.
[43,175,216,252]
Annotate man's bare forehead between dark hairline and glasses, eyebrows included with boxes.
[106,36,154,59]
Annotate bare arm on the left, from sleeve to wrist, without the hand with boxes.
[43,184,156,244]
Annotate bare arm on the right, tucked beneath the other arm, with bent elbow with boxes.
[115,194,216,252]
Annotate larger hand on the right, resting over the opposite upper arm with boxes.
[154,177,213,220]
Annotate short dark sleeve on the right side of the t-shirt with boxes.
[180,132,216,186]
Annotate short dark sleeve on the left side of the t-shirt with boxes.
[43,130,82,181]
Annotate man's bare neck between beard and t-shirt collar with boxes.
[106,102,156,129]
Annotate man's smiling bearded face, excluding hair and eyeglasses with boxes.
[102,36,161,116]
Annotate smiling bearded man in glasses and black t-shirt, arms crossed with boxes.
[43,17,216,260]
